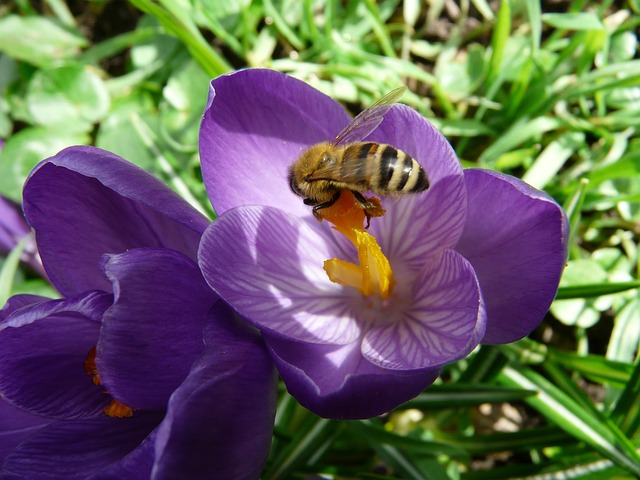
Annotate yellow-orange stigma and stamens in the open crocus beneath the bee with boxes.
[318,190,395,300]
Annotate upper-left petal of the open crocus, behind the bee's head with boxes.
[200,69,351,216]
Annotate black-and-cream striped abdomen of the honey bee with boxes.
[341,142,429,195]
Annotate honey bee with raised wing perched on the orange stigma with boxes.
[289,87,429,227]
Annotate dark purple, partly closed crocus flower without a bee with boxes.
[0,147,276,479]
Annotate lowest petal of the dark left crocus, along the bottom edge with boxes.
[0,413,161,480]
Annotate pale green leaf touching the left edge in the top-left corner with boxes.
[0,15,87,67]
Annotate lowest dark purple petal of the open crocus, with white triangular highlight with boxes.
[266,334,439,419]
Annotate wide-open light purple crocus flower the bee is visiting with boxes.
[199,70,567,418]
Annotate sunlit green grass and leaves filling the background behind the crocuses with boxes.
[0,0,640,479]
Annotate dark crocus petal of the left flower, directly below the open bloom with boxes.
[153,302,277,480]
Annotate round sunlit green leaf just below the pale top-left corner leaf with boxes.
[27,65,111,132]
